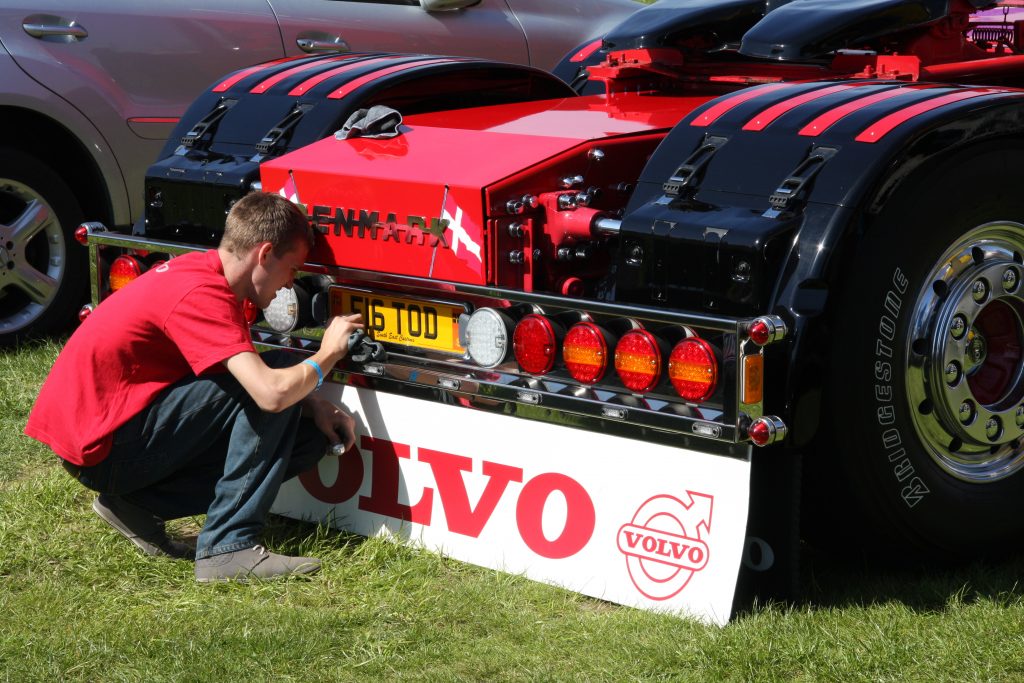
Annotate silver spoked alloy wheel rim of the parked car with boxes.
[0,178,68,334]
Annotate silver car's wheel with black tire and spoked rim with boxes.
[0,147,88,346]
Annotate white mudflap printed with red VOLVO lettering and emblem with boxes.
[273,385,751,624]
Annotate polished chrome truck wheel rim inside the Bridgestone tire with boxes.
[905,221,1024,483]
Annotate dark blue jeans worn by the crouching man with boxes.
[79,373,328,559]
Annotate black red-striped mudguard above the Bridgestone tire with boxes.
[614,81,1024,443]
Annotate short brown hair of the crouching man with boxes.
[220,193,314,258]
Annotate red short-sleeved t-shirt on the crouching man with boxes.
[25,250,255,465]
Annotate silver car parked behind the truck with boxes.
[0,0,639,345]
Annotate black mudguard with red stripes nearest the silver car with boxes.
[135,53,575,244]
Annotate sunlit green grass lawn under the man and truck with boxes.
[6,343,1024,683]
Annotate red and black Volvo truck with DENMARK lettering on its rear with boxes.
[77,0,1024,623]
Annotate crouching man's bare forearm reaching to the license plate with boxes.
[224,313,362,413]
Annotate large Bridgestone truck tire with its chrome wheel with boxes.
[817,143,1024,559]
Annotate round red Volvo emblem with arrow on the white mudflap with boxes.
[617,492,714,600]
